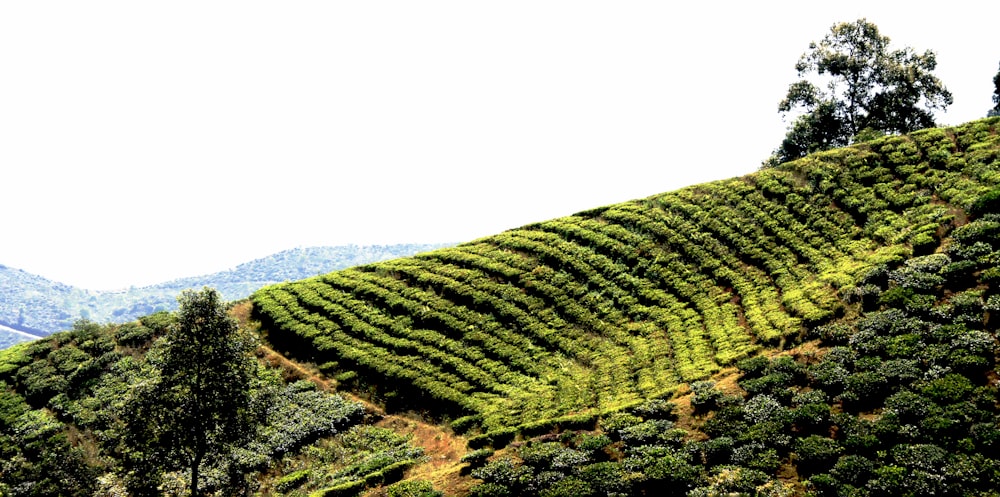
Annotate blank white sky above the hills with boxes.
[0,0,1000,289]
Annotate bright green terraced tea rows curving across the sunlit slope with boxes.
[252,118,1000,436]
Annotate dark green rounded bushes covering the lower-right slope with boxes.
[464,209,1000,497]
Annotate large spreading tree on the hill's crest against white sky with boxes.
[765,19,952,165]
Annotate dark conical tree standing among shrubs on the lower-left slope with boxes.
[124,288,259,496]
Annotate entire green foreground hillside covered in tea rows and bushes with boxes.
[0,118,1000,496]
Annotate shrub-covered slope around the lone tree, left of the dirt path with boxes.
[0,295,430,497]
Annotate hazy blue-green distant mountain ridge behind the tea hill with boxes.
[0,244,448,340]
